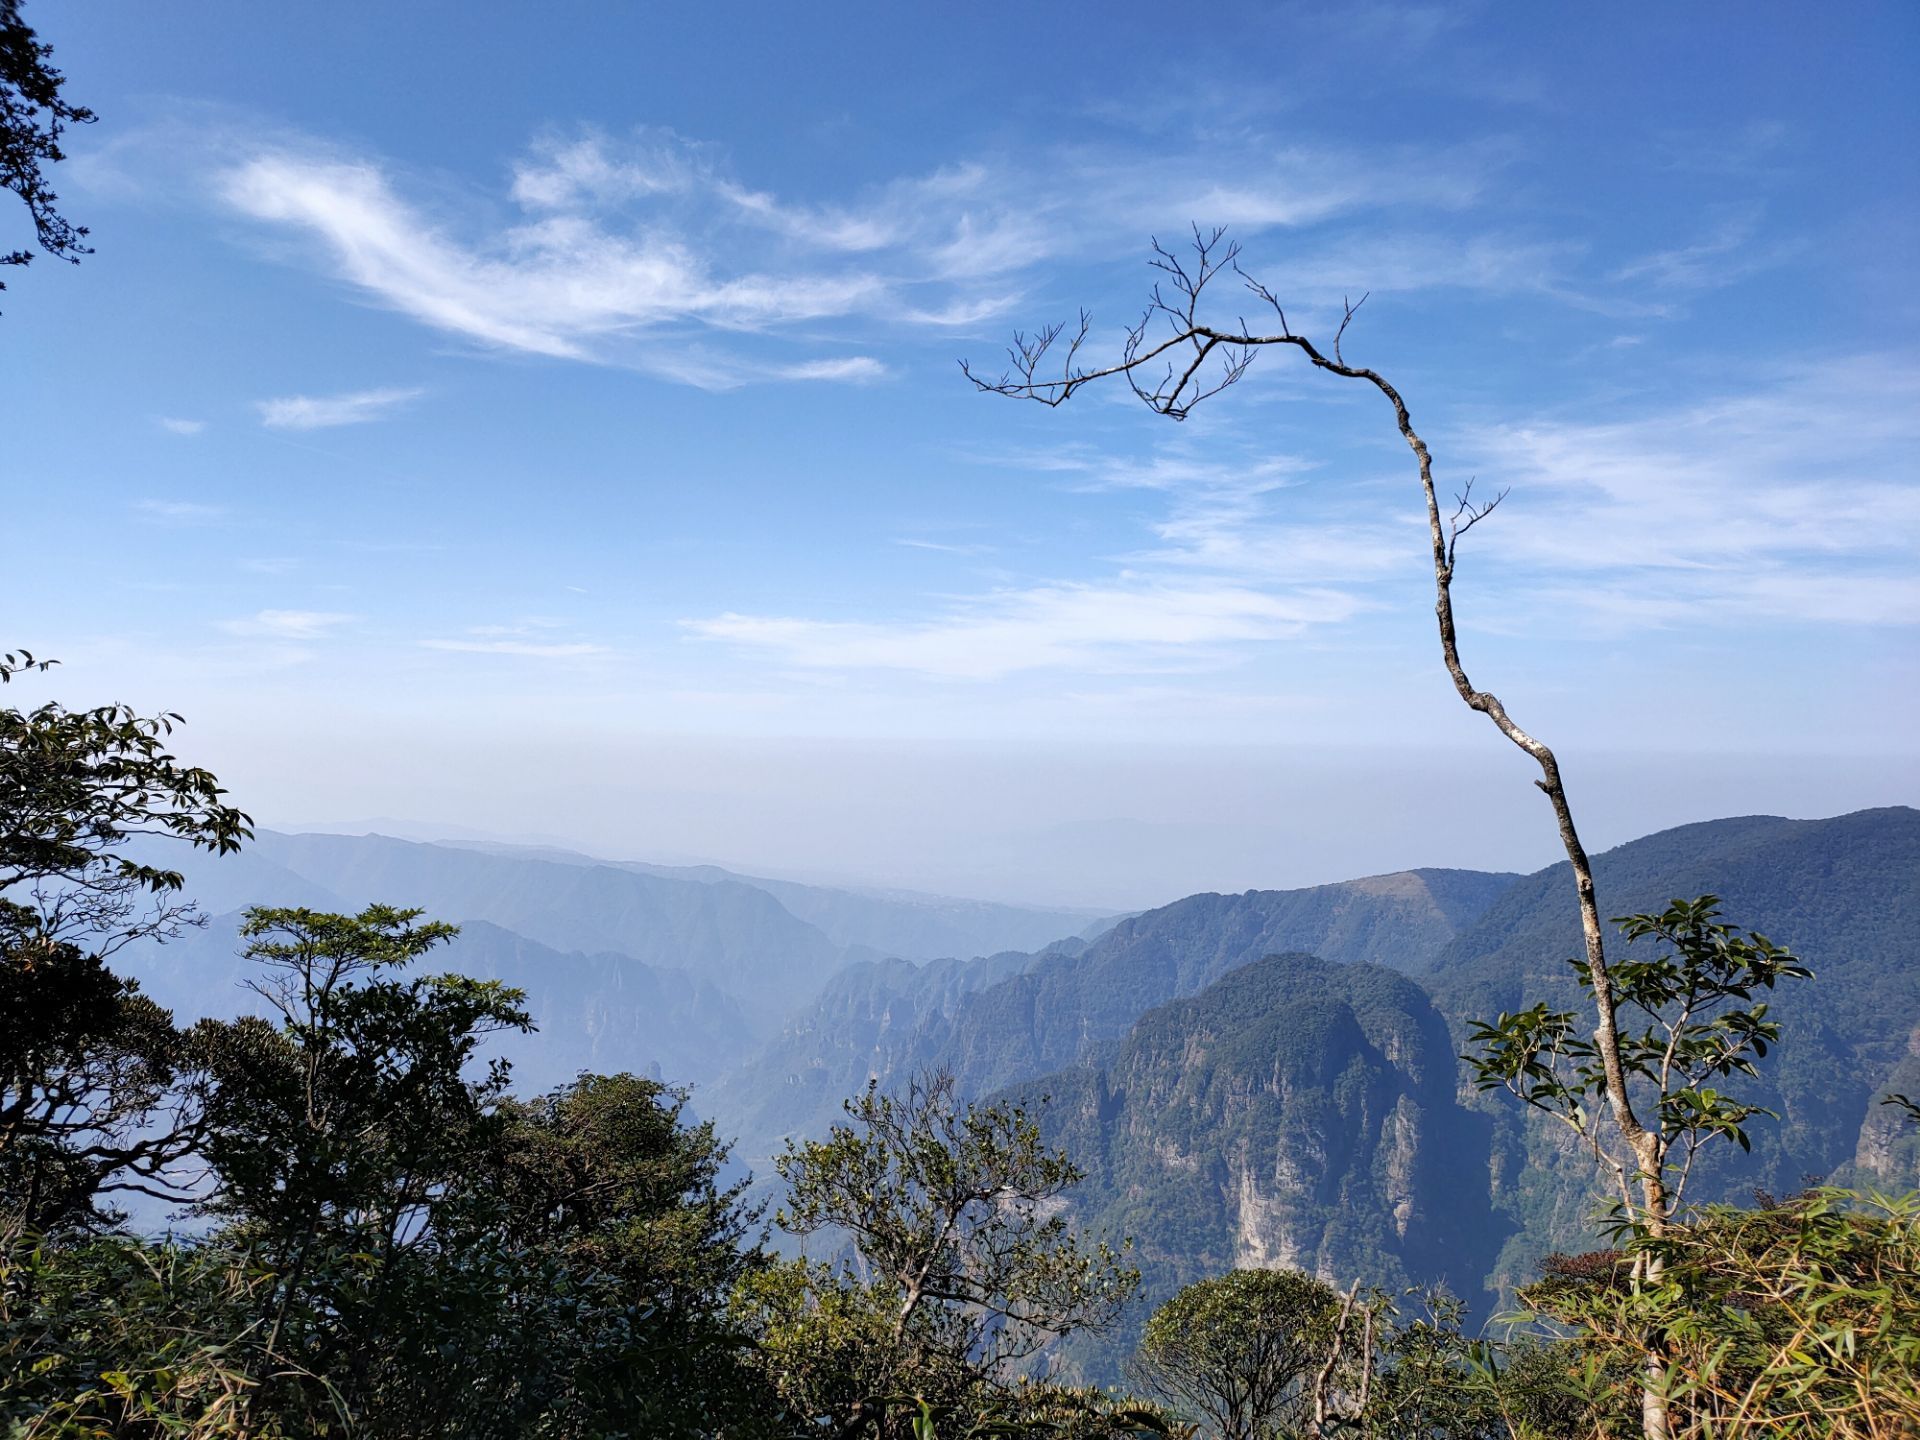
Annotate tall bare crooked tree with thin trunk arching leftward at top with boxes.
[960,227,1674,1440]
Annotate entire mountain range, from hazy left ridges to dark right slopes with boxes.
[116,808,1920,1320]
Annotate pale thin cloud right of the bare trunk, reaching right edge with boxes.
[1463,357,1920,624]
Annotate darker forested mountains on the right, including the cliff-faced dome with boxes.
[705,808,1920,1373]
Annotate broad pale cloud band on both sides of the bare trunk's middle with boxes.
[710,357,1920,682]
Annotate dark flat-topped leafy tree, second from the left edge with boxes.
[190,904,530,1423]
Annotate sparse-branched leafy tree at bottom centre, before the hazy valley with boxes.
[745,1075,1139,1436]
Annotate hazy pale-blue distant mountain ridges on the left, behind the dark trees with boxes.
[116,829,1100,1085]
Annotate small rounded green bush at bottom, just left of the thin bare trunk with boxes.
[1129,1269,1340,1440]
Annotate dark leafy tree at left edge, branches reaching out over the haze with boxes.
[0,653,252,1229]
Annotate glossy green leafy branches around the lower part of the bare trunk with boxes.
[1465,895,1812,1223]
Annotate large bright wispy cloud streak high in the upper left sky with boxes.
[217,129,1505,384]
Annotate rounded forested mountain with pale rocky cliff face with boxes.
[1012,954,1501,1375]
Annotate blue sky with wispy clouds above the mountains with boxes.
[0,0,1920,904]
